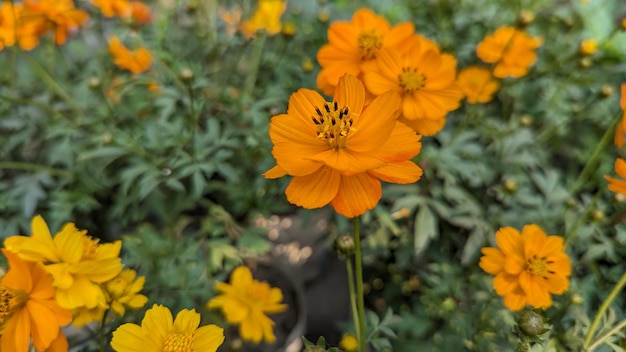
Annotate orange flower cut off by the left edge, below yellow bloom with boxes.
[0,248,72,352]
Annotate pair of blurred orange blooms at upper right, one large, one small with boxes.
[457,26,542,104]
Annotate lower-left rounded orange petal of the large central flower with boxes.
[285,166,341,209]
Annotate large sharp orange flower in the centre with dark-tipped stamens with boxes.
[264,75,422,218]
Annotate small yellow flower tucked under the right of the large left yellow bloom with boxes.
[72,269,148,326]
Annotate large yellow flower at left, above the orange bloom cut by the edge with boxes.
[4,215,122,309]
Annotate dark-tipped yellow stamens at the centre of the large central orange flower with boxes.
[311,101,355,149]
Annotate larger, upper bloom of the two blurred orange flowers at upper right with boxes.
[476,26,543,78]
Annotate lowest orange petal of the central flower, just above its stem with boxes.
[332,173,382,218]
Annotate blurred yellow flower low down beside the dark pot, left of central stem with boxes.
[207,266,287,343]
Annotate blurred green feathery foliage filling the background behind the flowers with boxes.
[0,0,626,352]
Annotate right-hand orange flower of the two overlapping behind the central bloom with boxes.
[363,35,463,136]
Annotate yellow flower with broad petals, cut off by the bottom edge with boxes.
[111,304,224,352]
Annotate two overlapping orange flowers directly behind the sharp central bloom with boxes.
[317,9,463,135]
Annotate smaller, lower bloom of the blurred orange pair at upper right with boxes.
[456,66,500,104]
